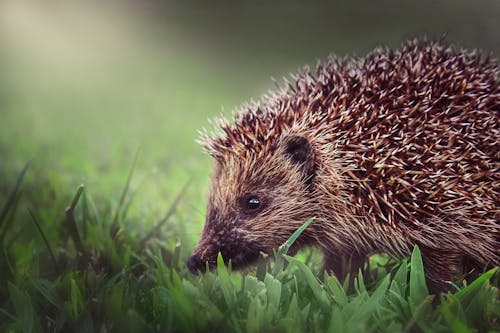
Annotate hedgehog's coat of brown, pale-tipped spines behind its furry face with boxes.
[203,40,500,228]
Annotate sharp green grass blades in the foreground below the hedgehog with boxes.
[0,164,500,332]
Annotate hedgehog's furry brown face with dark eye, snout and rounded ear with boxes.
[188,136,314,272]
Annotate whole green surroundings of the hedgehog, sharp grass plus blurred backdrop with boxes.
[0,1,500,332]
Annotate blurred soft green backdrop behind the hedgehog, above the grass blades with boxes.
[0,0,500,248]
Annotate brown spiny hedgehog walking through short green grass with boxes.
[187,39,500,293]
